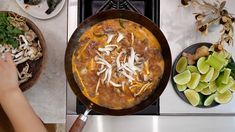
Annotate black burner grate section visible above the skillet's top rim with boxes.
[78,0,160,26]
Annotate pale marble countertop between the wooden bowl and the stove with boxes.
[0,0,67,123]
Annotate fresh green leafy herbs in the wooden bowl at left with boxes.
[0,13,23,48]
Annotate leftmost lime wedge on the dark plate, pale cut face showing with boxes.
[173,70,191,85]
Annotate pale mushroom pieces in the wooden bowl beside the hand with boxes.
[0,30,42,84]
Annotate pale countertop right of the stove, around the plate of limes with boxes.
[160,0,235,115]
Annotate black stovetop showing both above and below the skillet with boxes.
[76,0,160,115]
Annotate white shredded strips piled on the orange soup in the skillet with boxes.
[94,32,152,96]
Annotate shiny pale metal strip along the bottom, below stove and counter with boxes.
[66,115,235,132]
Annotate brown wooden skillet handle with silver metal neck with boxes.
[69,109,91,132]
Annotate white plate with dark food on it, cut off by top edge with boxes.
[16,0,65,19]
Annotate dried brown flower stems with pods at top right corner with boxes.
[181,0,235,47]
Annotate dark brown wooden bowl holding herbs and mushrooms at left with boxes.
[0,11,47,91]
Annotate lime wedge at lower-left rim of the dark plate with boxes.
[184,89,200,106]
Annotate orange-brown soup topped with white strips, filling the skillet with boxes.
[72,19,164,109]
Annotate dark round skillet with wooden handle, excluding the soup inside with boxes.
[65,10,172,132]
